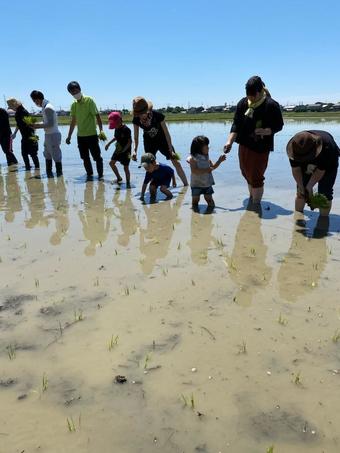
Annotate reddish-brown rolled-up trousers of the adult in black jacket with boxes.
[238,145,269,189]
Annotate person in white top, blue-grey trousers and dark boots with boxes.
[31,90,63,178]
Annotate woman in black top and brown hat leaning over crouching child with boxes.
[132,97,188,186]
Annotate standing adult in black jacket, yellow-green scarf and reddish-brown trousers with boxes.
[224,76,283,203]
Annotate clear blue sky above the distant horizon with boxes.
[0,0,340,108]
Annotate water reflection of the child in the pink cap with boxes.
[113,190,138,247]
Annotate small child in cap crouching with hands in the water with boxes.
[140,153,176,202]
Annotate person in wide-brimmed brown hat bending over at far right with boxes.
[287,130,339,216]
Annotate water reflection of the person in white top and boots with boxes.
[47,176,70,245]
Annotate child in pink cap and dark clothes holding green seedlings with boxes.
[105,112,132,189]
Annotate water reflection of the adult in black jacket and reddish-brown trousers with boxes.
[228,203,272,307]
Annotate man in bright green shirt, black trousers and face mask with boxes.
[66,81,103,179]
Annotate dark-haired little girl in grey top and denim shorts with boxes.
[187,135,226,211]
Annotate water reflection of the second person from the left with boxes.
[25,172,48,229]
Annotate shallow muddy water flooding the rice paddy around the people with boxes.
[0,122,340,453]
